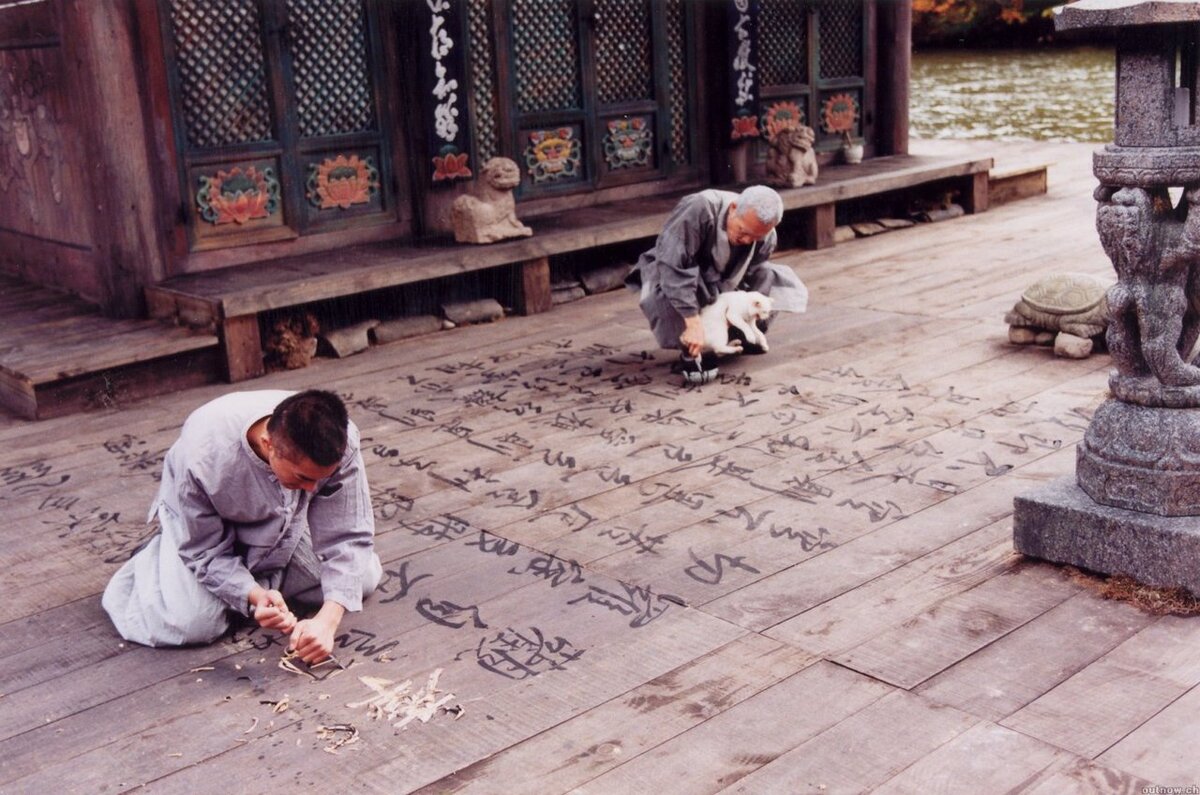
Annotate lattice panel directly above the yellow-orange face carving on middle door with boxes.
[512,0,582,113]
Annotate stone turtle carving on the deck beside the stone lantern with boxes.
[1004,273,1111,359]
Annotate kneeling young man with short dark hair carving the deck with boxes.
[103,390,382,663]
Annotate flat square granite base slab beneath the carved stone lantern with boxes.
[1013,478,1200,596]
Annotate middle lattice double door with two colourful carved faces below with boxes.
[502,0,691,196]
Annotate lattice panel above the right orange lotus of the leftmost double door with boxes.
[287,0,376,138]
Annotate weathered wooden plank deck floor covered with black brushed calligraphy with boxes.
[0,144,1200,795]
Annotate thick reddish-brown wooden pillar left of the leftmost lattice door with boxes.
[61,0,164,317]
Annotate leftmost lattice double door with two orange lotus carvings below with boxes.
[161,0,395,250]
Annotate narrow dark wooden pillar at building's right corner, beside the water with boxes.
[877,0,912,155]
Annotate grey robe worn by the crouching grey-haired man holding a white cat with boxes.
[625,189,809,348]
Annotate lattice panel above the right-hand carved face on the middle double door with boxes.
[594,0,654,104]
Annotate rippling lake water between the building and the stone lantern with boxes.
[908,47,1116,143]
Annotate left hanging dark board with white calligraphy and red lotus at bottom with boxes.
[418,0,472,185]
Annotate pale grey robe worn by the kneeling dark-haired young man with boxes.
[103,390,382,646]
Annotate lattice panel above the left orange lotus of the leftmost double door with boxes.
[170,0,274,149]
